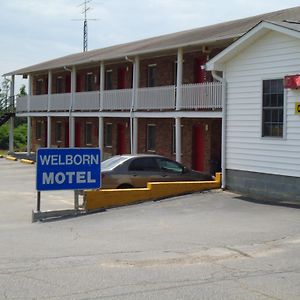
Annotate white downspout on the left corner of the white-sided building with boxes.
[211,70,227,190]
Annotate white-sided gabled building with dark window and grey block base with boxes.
[207,21,300,201]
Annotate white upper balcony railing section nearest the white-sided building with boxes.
[181,82,222,109]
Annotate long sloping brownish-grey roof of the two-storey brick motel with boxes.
[5,6,300,75]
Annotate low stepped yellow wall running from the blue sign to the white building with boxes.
[84,173,221,211]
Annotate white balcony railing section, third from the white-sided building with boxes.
[102,89,132,110]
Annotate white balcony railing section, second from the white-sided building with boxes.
[136,85,175,110]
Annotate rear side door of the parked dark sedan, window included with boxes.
[128,157,163,187]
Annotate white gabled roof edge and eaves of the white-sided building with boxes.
[206,20,300,71]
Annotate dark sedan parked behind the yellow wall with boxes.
[101,154,214,189]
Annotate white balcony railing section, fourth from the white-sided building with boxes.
[73,91,100,111]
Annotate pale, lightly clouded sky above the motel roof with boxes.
[0,0,300,90]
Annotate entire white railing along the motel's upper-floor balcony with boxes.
[16,82,222,113]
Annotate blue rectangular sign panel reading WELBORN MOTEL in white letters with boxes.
[36,148,101,191]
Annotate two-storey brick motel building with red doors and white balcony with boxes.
[5,7,300,180]
